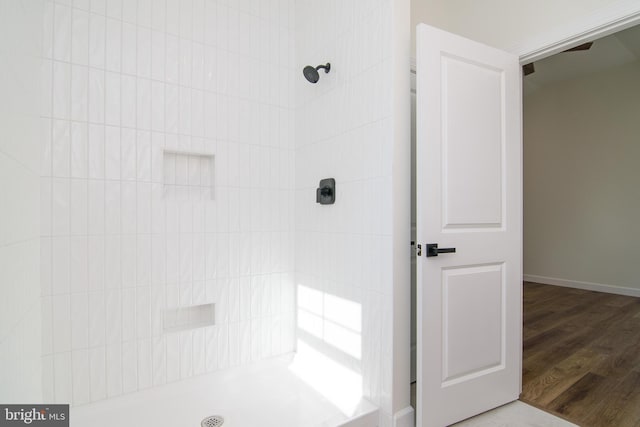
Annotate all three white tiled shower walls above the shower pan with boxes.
[0,0,408,425]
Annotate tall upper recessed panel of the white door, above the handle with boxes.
[442,55,504,229]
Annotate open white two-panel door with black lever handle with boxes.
[416,24,522,427]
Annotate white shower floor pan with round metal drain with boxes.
[70,357,378,427]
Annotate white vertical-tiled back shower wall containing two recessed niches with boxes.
[40,0,295,405]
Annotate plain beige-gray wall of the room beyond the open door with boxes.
[524,62,640,295]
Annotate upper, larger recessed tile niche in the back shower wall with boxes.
[162,150,215,200]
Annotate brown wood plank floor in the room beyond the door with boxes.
[520,282,640,427]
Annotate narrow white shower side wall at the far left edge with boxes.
[0,0,42,403]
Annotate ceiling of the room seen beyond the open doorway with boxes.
[522,25,640,96]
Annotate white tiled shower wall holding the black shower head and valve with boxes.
[296,0,394,426]
